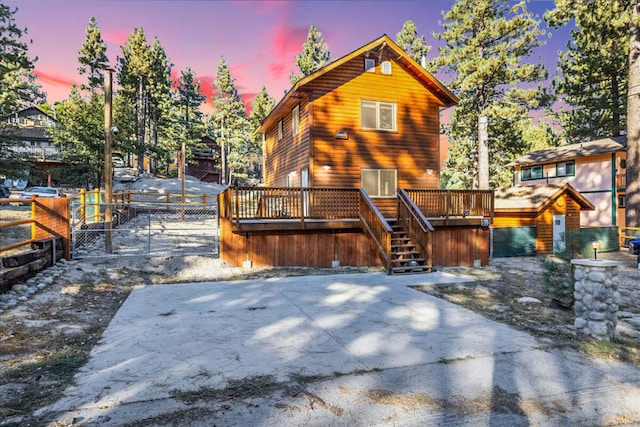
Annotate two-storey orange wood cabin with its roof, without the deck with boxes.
[256,35,457,215]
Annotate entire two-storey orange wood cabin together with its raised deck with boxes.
[221,35,493,271]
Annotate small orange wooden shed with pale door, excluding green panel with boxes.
[493,184,595,254]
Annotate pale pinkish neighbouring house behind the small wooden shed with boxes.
[509,136,627,231]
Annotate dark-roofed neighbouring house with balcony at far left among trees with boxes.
[5,107,63,185]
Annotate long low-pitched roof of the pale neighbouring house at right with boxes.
[507,135,627,166]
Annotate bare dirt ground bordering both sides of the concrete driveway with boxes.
[0,210,640,427]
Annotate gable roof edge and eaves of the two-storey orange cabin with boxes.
[254,34,458,134]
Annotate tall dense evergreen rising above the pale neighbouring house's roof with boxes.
[545,0,629,143]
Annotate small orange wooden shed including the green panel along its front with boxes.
[492,184,595,257]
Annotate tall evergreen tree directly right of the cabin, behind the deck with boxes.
[434,0,549,188]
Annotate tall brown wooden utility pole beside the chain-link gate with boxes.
[104,68,113,254]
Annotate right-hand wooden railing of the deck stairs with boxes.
[398,189,434,268]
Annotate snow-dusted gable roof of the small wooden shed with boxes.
[493,184,595,213]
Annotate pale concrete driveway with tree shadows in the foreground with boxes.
[42,273,640,426]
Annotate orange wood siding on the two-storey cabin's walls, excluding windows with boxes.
[265,46,442,188]
